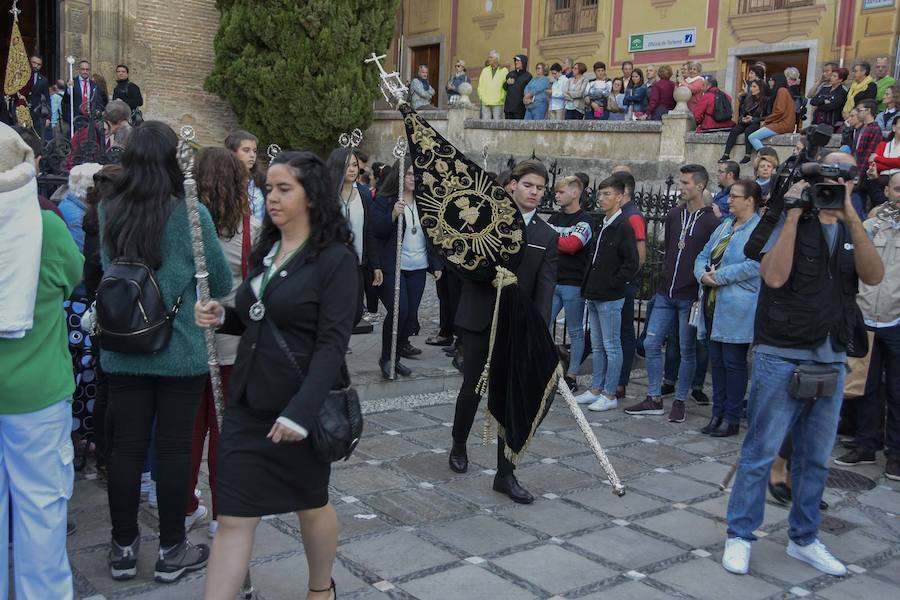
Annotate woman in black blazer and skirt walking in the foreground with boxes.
[195,152,359,600]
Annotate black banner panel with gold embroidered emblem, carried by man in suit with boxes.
[404,112,525,278]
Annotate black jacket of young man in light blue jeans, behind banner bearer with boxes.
[581,214,639,301]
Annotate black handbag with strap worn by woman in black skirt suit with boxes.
[264,317,363,462]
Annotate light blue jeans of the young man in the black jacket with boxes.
[585,299,625,397]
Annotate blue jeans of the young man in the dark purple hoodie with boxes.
[648,294,697,401]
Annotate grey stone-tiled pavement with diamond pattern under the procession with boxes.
[69,368,900,600]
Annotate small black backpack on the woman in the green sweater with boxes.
[94,258,181,354]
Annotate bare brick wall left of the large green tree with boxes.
[126,0,239,145]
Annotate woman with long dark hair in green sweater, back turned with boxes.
[100,121,231,583]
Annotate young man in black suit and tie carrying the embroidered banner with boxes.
[450,160,559,504]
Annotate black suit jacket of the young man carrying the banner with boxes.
[456,214,559,332]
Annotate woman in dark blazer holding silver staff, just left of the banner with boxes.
[372,157,442,379]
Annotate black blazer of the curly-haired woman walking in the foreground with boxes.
[219,243,362,431]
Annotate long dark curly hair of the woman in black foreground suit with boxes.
[250,152,351,268]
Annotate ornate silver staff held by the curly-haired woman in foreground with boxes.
[178,125,225,431]
